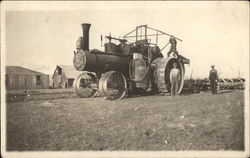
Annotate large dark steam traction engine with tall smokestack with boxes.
[73,24,189,100]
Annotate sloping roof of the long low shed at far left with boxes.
[6,66,47,75]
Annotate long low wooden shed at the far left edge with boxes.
[6,66,49,89]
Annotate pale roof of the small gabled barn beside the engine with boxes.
[52,65,82,78]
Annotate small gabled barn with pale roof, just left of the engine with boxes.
[52,65,82,88]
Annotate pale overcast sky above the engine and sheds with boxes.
[2,1,249,77]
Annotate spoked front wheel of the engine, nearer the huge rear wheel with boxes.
[99,71,127,100]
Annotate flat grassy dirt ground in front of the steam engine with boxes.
[6,90,244,151]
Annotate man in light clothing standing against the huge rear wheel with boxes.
[170,63,180,96]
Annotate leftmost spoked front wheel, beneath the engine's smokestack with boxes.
[73,72,98,98]
